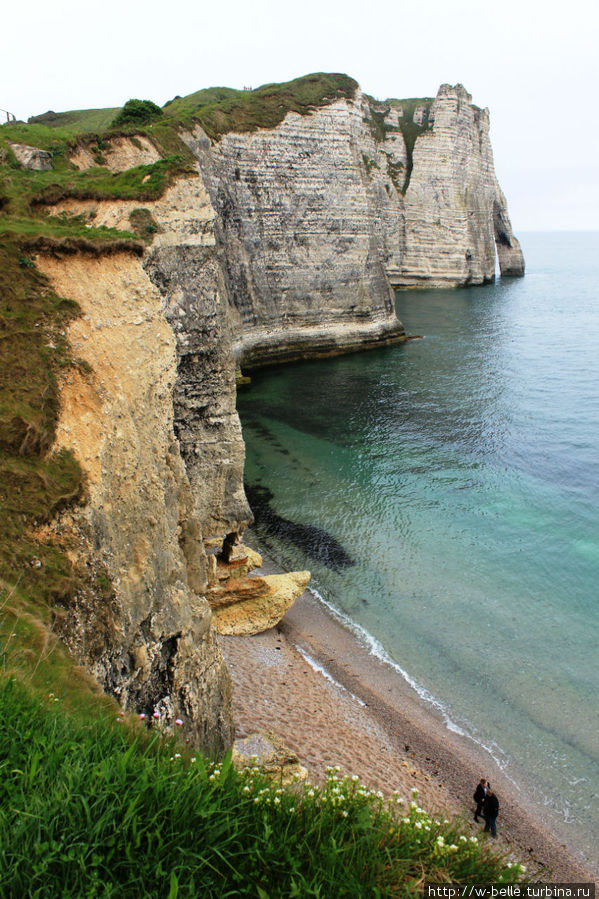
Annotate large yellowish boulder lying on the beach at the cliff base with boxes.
[206,571,310,636]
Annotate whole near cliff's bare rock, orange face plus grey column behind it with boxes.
[38,167,251,753]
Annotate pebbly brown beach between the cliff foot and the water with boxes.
[220,562,597,882]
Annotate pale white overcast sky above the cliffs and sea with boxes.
[0,0,599,233]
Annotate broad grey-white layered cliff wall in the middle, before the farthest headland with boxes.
[186,100,403,366]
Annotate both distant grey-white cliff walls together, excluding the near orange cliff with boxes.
[184,85,524,366]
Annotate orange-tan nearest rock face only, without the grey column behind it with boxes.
[38,256,232,752]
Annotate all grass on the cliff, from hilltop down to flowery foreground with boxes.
[0,75,515,897]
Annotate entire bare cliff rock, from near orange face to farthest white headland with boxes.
[19,75,524,752]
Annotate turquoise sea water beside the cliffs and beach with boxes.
[238,233,599,860]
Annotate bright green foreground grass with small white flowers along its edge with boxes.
[0,679,522,899]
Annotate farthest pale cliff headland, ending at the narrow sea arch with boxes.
[394,84,524,287]
